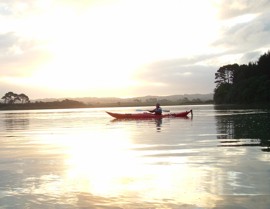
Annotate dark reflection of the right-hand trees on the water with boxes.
[215,110,270,152]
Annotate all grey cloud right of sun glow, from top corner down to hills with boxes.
[129,0,270,95]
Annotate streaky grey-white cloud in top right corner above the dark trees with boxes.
[209,0,270,64]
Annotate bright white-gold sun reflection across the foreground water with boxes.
[32,125,219,207]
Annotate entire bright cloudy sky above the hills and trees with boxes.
[0,0,270,99]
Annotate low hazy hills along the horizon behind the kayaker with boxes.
[35,94,213,105]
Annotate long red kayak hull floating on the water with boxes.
[106,110,193,119]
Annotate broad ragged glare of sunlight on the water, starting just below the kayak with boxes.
[25,116,217,208]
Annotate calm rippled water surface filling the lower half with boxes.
[0,105,270,209]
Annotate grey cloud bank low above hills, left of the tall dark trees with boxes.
[133,56,218,94]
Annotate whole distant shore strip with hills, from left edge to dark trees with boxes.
[0,94,214,110]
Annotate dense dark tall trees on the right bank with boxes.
[214,51,270,104]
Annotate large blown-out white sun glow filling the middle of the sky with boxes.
[6,0,216,96]
